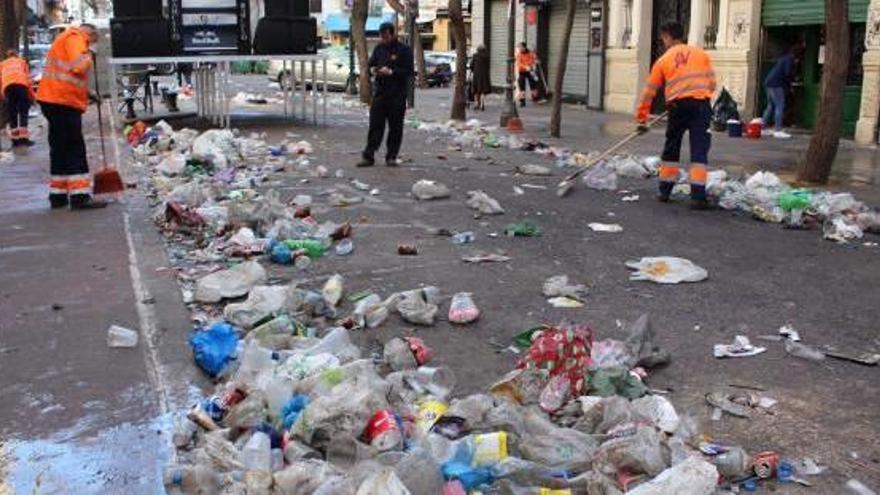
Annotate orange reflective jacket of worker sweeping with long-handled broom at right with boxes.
[636,43,715,122]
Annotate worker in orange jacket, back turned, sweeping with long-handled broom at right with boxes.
[636,22,715,209]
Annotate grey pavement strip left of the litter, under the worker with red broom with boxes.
[0,111,196,494]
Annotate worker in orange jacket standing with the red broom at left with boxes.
[37,24,107,210]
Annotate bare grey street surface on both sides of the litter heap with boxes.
[0,80,880,494]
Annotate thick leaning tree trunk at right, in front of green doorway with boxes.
[798,0,849,184]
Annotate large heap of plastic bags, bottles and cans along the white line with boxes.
[122,123,832,495]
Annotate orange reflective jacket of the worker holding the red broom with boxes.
[37,28,92,112]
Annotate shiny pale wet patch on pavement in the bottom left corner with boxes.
[0,417,172,495]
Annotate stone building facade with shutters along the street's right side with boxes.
[472,0,880,143]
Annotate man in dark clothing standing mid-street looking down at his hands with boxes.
[357,22,414,167]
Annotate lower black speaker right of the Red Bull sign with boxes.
[254,17,318,55]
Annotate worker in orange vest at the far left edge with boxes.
[0,50,34,146]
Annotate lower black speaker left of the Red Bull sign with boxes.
[110,17,173,57]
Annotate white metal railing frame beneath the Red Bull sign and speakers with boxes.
[107,55,327,127]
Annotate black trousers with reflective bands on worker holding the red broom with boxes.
[40,103,92,201]
